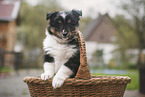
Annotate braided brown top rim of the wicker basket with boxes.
[24,75,131,86]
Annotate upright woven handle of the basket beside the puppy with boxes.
[75,31,91,79]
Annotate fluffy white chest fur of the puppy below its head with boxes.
[43,31,77,73]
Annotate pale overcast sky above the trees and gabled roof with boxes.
[26,0,122,18]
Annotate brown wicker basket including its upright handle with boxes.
[24,32,131,97]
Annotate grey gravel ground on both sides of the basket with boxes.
[0,69,145,97]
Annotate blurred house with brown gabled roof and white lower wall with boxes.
[84,14,117,65]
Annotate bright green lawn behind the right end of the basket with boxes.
[92,70,139,90]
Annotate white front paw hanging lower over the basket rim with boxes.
[52,76,65,89]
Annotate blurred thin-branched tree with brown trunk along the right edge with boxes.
[122,0,145,65]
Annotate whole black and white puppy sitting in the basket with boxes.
[41,10,82,88]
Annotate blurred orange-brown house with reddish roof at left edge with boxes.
[0,0,20,66]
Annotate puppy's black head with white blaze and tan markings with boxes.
[46,10,82,41]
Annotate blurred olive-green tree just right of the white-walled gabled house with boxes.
[113,15,138,64]
